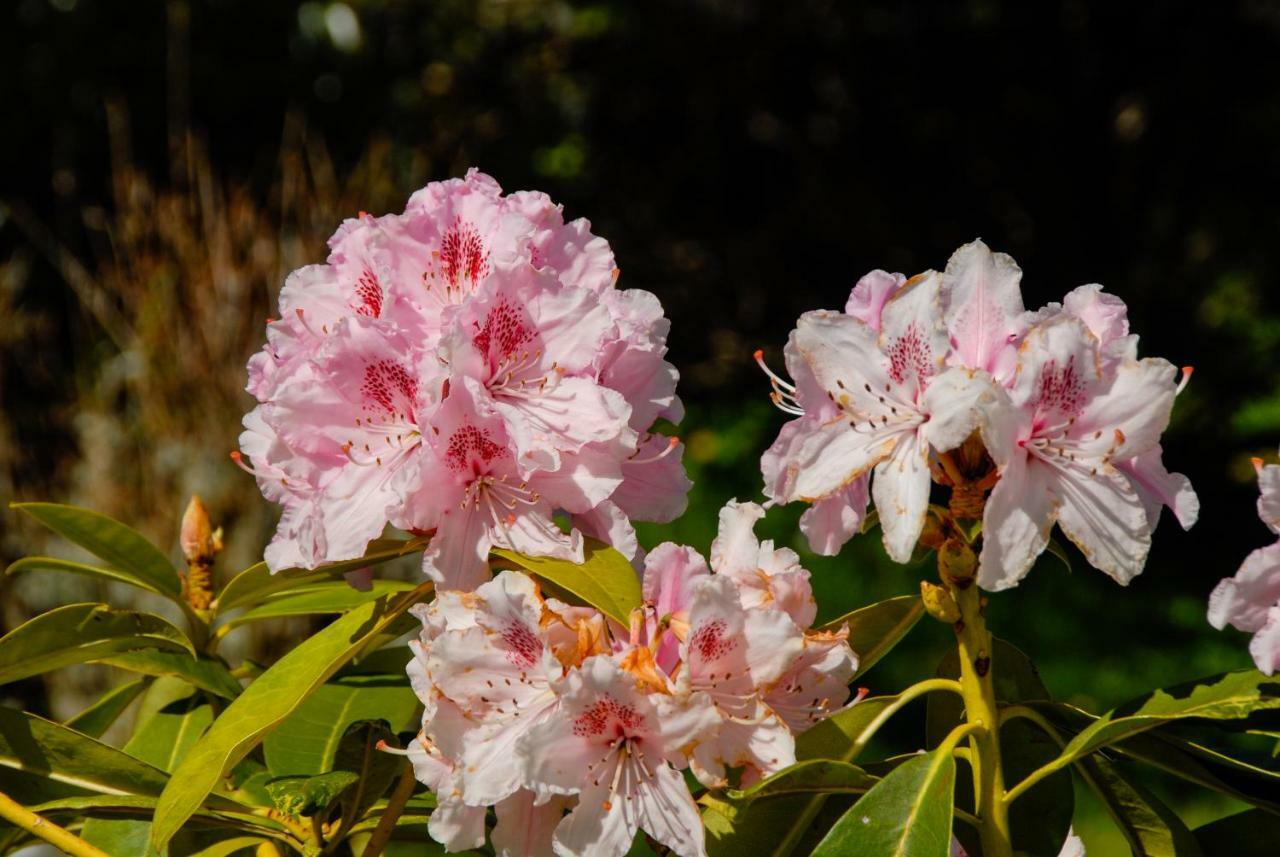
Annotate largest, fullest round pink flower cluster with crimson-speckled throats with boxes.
[237,170,690,588]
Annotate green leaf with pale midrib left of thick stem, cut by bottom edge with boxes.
[813,746,956,857]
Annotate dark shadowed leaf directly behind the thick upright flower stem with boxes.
[925,637,1075,857]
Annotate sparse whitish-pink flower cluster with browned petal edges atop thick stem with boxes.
[758,240,1199,590]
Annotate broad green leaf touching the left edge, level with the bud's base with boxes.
[0,604,195,684]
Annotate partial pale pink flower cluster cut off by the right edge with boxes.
[1208,458,1280,675]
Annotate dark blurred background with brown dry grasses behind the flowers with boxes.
[0,0,1280,844]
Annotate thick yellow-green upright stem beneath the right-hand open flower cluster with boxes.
[952,588,1012,857]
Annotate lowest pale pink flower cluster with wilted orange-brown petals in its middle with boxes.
[408,503,858,857]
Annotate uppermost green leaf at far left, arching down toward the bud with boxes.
[9,503,182,601]
